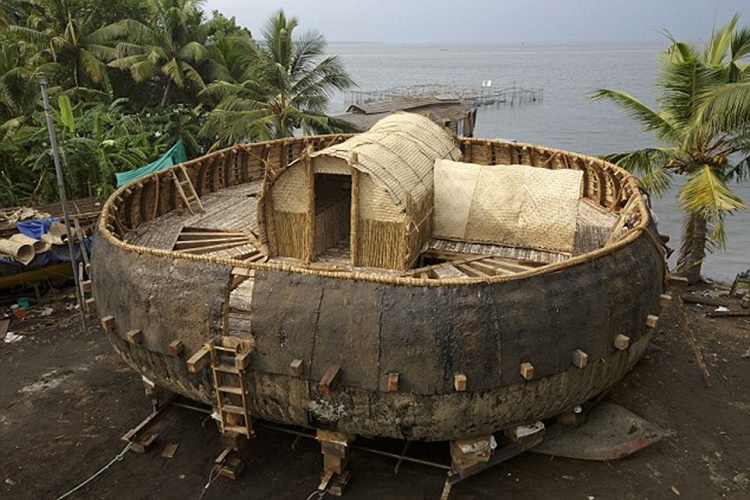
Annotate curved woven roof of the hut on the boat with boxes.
[312,113,461,207]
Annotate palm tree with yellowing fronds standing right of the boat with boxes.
[593,15,750,283]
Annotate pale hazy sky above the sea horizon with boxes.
[203,0,750,44]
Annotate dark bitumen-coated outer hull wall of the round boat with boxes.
[92,228,665,441]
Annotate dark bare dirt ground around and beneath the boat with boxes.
[0,284,750,500]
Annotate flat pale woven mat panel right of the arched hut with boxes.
[434,160,583,252]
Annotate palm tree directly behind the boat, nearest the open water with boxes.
[202,10,354,143]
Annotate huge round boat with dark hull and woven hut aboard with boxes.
[92,115,666,440]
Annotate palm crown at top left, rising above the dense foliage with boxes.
[103,0,211,107]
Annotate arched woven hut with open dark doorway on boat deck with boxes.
[259,113,461,270]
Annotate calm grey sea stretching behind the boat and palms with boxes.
[328,42,750,282]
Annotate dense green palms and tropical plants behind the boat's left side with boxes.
[0,0,351,206]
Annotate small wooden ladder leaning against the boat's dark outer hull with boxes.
[208,337,253,438]
